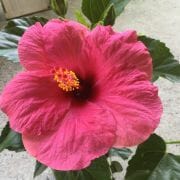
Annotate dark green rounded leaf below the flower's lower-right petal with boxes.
[126,134,166,180]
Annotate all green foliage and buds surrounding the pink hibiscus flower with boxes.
[0,0,180,180]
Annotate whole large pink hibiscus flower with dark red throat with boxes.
[0,19,162,171]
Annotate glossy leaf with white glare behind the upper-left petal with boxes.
[0,17,47,62]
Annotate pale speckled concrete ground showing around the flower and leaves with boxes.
[0,0,180,180]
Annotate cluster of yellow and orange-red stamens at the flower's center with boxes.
[53,68,80,92]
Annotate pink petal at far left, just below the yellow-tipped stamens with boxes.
[0,71,70,135]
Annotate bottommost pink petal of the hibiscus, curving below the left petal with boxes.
[23,103,116,171]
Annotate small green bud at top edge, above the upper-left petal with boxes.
[51,0,68,17]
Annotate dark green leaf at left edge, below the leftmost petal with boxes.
[0,123,24,152]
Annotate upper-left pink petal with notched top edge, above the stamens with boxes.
[18,19,88,70]
